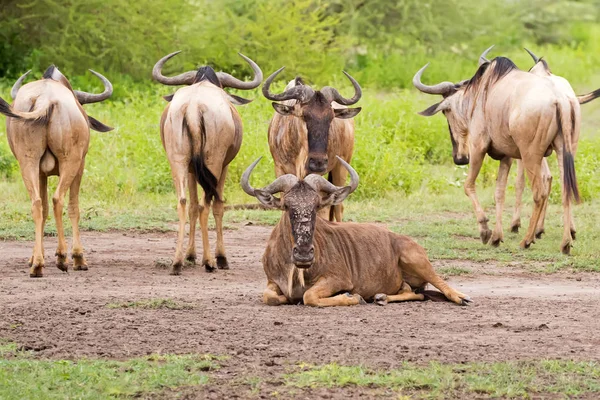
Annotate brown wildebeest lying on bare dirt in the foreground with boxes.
[241,157,470,307]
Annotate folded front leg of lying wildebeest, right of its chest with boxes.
[303,278,366,307]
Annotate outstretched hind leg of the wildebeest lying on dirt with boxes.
[399,237,471,305]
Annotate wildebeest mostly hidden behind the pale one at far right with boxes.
[508,49,600,239]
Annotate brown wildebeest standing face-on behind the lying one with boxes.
[263,67,362,222]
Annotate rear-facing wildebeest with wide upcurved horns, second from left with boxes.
[152,52,262,275]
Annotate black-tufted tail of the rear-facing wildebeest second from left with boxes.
[184,105,221,204]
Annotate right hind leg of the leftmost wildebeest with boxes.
[52,159,81,272]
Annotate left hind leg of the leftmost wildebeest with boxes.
[19,161,47,278]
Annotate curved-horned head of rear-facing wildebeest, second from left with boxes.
[152,51,263,105]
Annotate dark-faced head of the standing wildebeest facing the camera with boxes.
[262,67,362,174]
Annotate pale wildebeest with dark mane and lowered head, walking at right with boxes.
[413,57,579,254]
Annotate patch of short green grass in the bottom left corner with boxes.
[0,343,221,400]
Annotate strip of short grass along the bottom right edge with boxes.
[285,360,600,399]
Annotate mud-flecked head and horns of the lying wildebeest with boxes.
[241,157,359,268]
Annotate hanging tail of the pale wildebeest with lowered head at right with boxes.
[556,102,581,203]
